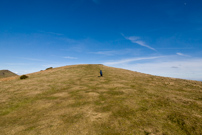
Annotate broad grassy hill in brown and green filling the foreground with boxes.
[0,65,202,135]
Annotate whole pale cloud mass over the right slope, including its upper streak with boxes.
[104,55,202,81]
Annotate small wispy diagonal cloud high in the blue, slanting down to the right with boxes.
[122,34,156,51]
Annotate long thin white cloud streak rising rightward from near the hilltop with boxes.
[103,56,164,65]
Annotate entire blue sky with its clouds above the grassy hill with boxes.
[0,0,202,80]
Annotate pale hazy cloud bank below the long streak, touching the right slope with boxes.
[119,58,202,81]
